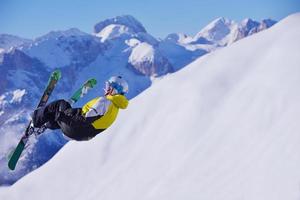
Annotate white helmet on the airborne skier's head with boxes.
[105,76,129,95]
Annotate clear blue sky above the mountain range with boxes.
[0,0,300,38]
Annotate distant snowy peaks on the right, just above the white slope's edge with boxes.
[159,17,276,71]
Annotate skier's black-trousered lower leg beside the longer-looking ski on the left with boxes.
[32,100,71,128]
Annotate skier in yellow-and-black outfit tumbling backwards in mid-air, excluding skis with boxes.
[32,76,128,141]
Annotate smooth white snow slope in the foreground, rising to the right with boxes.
[0,13,300,200]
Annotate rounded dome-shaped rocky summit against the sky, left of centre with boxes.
[94,15,147,33]
